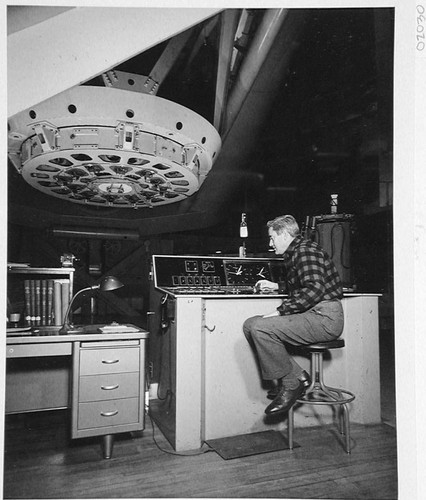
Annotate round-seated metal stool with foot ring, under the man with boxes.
[288,339,355,453]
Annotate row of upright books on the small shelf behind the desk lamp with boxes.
[24,279,70,326]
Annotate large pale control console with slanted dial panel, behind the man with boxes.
[150,255,381,451]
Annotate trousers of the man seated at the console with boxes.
[243,300,344,380]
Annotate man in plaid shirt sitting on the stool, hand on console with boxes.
[243,215,343,415]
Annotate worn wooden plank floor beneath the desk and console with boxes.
[4,411,397,500]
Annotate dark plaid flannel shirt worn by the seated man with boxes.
[277,236,343,315]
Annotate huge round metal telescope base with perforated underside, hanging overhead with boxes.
[8,86,221,209]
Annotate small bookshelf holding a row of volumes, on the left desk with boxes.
[7,264,75,330]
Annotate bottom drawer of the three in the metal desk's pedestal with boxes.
[77,398,139,430]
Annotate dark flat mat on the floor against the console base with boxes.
[206,431,299,460]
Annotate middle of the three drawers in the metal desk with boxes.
[78,372,140,402]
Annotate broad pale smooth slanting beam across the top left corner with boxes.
[7,6,222,116]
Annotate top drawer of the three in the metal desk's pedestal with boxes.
[80,347,139,375]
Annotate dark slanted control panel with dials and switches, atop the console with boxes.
[153,255,284,294]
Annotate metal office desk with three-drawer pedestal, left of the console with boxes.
[6,330,149,458]
